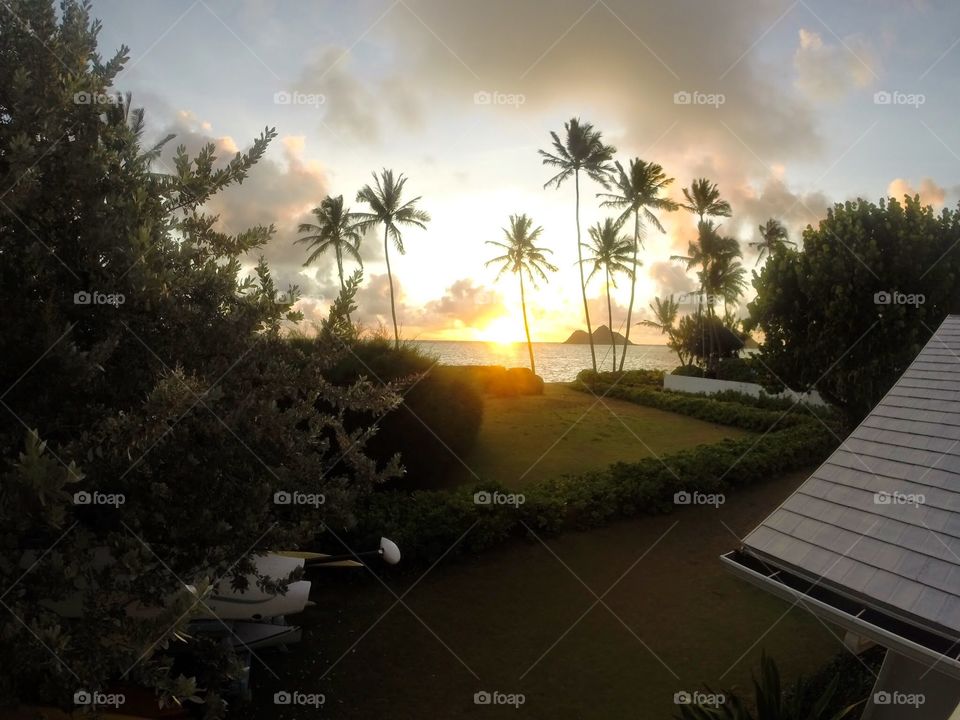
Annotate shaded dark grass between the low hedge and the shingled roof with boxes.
[241,470,841,720]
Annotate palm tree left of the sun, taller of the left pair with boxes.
[356,169,430,348]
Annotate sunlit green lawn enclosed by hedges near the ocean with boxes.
[456,384,749,487]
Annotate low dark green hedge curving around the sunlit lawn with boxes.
[344,388,836,566]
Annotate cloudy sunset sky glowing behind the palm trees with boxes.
[93,0,960,342]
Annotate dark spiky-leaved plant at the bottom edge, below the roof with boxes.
[675,654,863,720]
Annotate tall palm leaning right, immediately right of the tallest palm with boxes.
[598,158,680,372]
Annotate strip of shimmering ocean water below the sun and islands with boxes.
[414,340,680,382]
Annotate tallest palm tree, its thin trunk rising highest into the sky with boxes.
[539,118,616,372]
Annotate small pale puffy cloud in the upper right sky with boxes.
[793,28,876,101]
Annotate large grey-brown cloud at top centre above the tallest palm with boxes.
[372,0,821,158]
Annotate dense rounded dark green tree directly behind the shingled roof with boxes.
[745,197,960,421]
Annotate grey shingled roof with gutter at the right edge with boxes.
[724,316,960,668]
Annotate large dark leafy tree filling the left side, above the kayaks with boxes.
[0,0,399,717]
